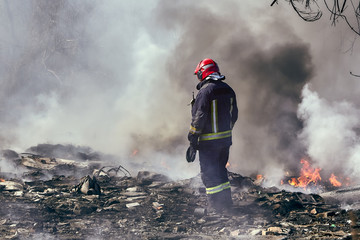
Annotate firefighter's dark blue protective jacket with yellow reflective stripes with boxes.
[188,76,238,149]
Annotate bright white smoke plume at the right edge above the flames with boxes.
[298,85,360,181]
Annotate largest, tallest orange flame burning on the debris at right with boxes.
[288,159,321,189]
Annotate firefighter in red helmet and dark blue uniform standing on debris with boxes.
[186,58,238,212]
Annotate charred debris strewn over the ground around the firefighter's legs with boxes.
[0,146,360,239]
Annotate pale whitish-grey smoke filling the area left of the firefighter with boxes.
[0,0,197,180]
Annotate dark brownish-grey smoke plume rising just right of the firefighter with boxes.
[157,1,313,176]
